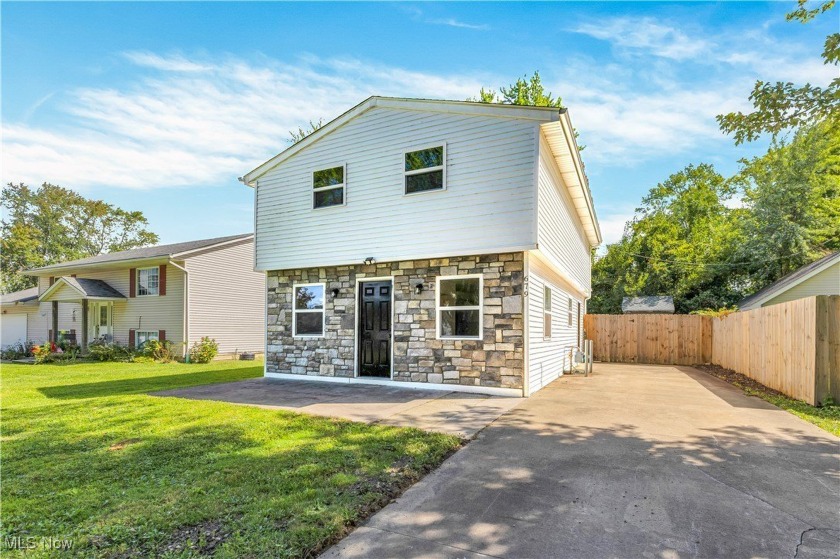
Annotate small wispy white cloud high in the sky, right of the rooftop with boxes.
[573,17,710,60]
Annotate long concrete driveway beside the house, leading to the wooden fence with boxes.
[324,364,840,558]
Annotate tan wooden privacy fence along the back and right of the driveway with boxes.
[584,296,840,405]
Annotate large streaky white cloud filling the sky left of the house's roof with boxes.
[2,52,484,189]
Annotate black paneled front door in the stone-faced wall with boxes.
[359,281,391,378]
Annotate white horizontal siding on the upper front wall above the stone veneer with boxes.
[256,108,539,270]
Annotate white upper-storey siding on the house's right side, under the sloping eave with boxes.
[537,137,592,296]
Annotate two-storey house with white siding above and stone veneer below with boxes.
[241,97,601,396]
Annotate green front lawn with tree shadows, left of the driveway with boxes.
[0,361,460,558]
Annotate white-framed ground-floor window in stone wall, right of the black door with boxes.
[437,276,482,340]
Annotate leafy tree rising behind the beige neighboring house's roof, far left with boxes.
[0,183,158,293]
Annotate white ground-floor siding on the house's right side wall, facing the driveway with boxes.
[526,258,583,394]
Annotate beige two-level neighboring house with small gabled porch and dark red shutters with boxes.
[21,234,265,355]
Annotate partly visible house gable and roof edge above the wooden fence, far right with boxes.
[738,252,840,311]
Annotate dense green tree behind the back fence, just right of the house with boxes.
[588,164,743,314]
